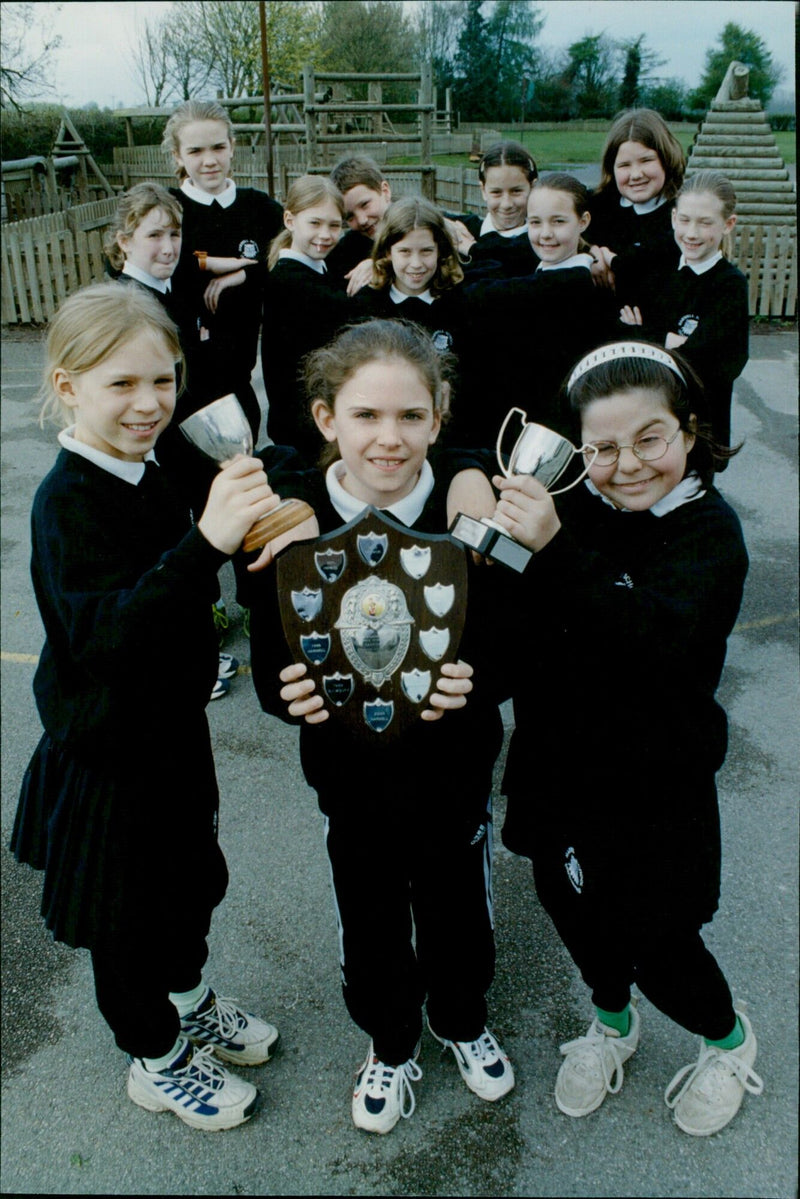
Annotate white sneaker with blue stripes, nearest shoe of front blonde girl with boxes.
[127,1041,258,1132]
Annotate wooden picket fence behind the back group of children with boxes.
[1,191,798,325]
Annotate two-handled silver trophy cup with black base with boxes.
[450,408,597,571]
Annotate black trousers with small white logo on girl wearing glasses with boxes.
[531,830,736,1041]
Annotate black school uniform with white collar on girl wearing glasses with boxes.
[503,476,747,1040]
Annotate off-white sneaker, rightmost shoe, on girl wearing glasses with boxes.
[664,1012,764,1137]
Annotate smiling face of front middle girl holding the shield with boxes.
[312,359,441,508]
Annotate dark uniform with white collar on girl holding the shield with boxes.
[251,453,503,1065]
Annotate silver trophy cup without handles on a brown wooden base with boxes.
[178,394,314,553]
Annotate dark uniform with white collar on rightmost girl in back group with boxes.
[626,252,750,446]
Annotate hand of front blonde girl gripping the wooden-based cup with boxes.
[197,454,281,554]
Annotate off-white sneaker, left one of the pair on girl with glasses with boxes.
[555,1005,639,1116]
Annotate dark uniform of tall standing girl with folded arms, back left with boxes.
[170,180,283,441]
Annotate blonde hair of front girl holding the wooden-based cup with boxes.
[38,282,184,426]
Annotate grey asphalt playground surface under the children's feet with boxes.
[0,331,800,1199]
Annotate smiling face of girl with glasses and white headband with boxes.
[581,387,694,512]
